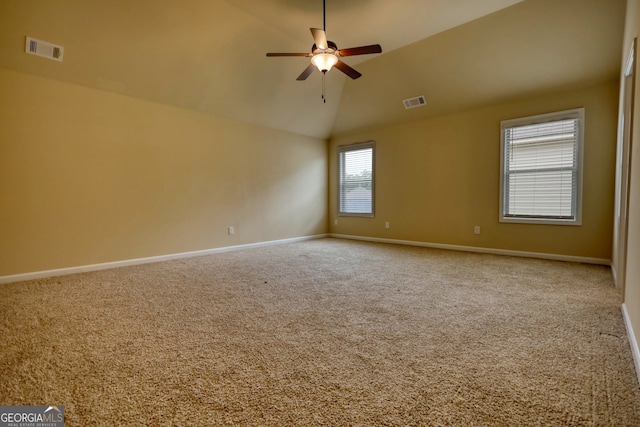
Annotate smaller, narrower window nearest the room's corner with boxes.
[338,142,373,216]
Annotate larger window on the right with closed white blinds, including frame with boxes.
[500,108,584,225]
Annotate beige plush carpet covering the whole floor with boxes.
[0,239,640,427]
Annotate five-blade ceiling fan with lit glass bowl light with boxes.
[267,0,382,80]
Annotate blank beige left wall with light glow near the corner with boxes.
[0,69,328,276]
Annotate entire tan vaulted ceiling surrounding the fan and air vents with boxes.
[0,0,625,138]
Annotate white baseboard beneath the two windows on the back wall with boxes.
[329,234,611,266]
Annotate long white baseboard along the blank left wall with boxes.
[0,234,328,285]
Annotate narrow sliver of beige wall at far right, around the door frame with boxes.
[622,0,640,378]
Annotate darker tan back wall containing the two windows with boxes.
[329,81,619,260]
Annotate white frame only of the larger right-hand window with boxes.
[499,108,585,225]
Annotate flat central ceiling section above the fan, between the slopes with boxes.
[227,0,522,56]
